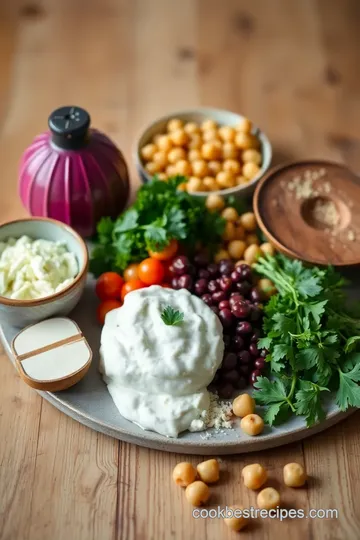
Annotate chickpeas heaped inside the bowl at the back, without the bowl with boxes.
[140,118,262,193]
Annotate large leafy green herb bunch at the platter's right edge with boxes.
[255,255,360,426]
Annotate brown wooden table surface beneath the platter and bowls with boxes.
[0,0,360,540]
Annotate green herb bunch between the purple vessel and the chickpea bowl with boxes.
[90,176,225,276]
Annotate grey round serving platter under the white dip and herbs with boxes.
[0,277,360,455]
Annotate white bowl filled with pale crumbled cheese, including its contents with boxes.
[0,218,89,327]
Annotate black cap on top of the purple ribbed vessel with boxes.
[48,107,90,150]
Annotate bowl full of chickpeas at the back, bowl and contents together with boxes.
[135,108,272,197]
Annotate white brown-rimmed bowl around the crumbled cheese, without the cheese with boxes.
[0,218,89,328]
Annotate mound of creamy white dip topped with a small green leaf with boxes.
[100,285,224,437]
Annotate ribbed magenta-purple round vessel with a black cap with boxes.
[19,107,129,237]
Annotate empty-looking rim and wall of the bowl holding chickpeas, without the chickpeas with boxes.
[134,108,272,197]
